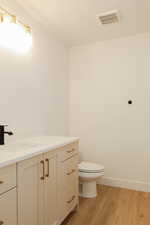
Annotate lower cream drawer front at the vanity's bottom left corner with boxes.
[0,188,17,225]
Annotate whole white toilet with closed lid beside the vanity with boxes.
[78,162,104,198]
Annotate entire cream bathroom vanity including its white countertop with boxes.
[0,137,78,225]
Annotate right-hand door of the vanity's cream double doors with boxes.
[44,152,57,225]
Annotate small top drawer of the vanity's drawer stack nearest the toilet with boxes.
[58,142,78,162]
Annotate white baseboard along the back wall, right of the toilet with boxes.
[98,177,150,192]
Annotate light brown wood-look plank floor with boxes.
[62,186,150,225]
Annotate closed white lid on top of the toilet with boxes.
[78,162,104,173]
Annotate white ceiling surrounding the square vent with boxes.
[2,0,150,46]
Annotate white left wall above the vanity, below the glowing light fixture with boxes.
[0,2,68,141]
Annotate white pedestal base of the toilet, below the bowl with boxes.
[79,181,97,198]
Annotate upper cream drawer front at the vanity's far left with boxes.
[0,164,16,194]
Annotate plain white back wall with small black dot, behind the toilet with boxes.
[70,34,150,190]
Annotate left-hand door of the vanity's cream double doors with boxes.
[18,155,44,225]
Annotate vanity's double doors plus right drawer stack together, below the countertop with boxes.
[17,143,78,225]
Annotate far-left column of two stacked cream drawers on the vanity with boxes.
[0,165,17,225]
